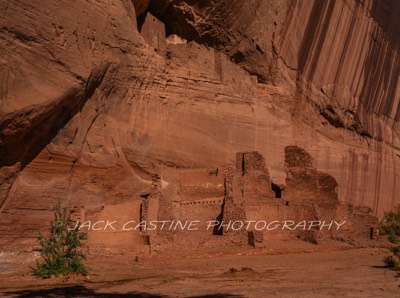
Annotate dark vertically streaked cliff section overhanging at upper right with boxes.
[277,1,400,134]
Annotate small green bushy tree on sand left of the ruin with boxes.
[34,202,88,278]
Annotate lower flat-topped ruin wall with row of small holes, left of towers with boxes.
[141,165,225,250]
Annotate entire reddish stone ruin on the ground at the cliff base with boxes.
[130,146,378,250]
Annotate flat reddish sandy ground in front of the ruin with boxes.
[0,242,400,298]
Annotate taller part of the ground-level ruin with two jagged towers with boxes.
[223,146,378,243]
